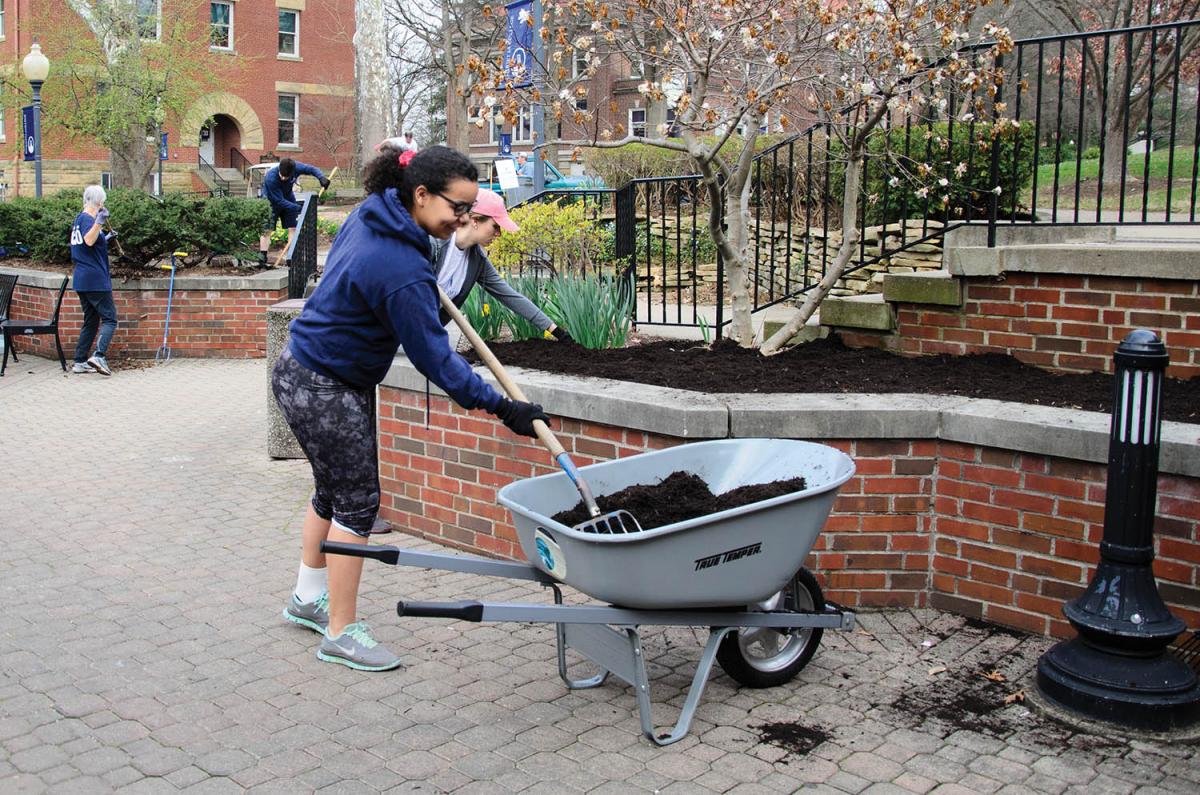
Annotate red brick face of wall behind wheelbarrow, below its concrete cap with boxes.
[379,387,1200,636]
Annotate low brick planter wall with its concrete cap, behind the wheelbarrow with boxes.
[379,364,1200,636]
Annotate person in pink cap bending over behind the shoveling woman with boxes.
[430,187,575,343]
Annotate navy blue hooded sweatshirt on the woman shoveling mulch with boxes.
[290,189,500,411]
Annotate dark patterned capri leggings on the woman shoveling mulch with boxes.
[271,349,379,538]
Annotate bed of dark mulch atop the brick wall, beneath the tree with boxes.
[477,337,1200,423]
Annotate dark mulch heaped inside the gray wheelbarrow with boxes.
[552,471,804,530]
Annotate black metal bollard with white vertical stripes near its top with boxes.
[1037,329,1200,731]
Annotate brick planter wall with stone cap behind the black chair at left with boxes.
[0,268,288,359]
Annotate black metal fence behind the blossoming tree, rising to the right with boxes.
[511,20,1200,328]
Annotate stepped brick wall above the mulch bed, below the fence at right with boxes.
[841,273,1200,378]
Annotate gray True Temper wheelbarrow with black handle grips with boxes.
[322,440,854,746]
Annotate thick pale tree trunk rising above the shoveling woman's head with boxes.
[354,0,394,165]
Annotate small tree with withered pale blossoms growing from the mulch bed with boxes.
[480,0,1012,353]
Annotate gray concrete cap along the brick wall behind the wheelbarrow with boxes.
[383,357,1200,477]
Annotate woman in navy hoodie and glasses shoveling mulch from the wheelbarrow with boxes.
[271,147,548,671]
